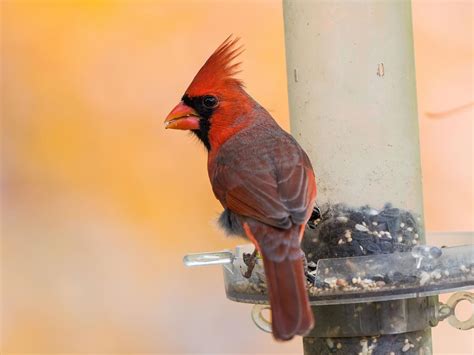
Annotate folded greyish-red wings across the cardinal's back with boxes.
[211,138,316,229]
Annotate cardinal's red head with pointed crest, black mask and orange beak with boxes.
[165,37,254,150]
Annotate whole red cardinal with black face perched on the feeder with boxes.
[165,37,316,340]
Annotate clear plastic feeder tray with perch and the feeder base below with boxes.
[184,244,474,354]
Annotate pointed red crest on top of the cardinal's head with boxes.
[186,35,243,96]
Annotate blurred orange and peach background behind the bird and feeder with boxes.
[1,0,474,354]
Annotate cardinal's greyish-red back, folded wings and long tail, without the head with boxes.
[209,117,316,340]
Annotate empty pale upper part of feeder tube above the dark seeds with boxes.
[283,0,422,215]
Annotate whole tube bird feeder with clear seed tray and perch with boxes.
[185,0,474,355]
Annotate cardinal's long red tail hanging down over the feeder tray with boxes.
[244,224,314,340]
